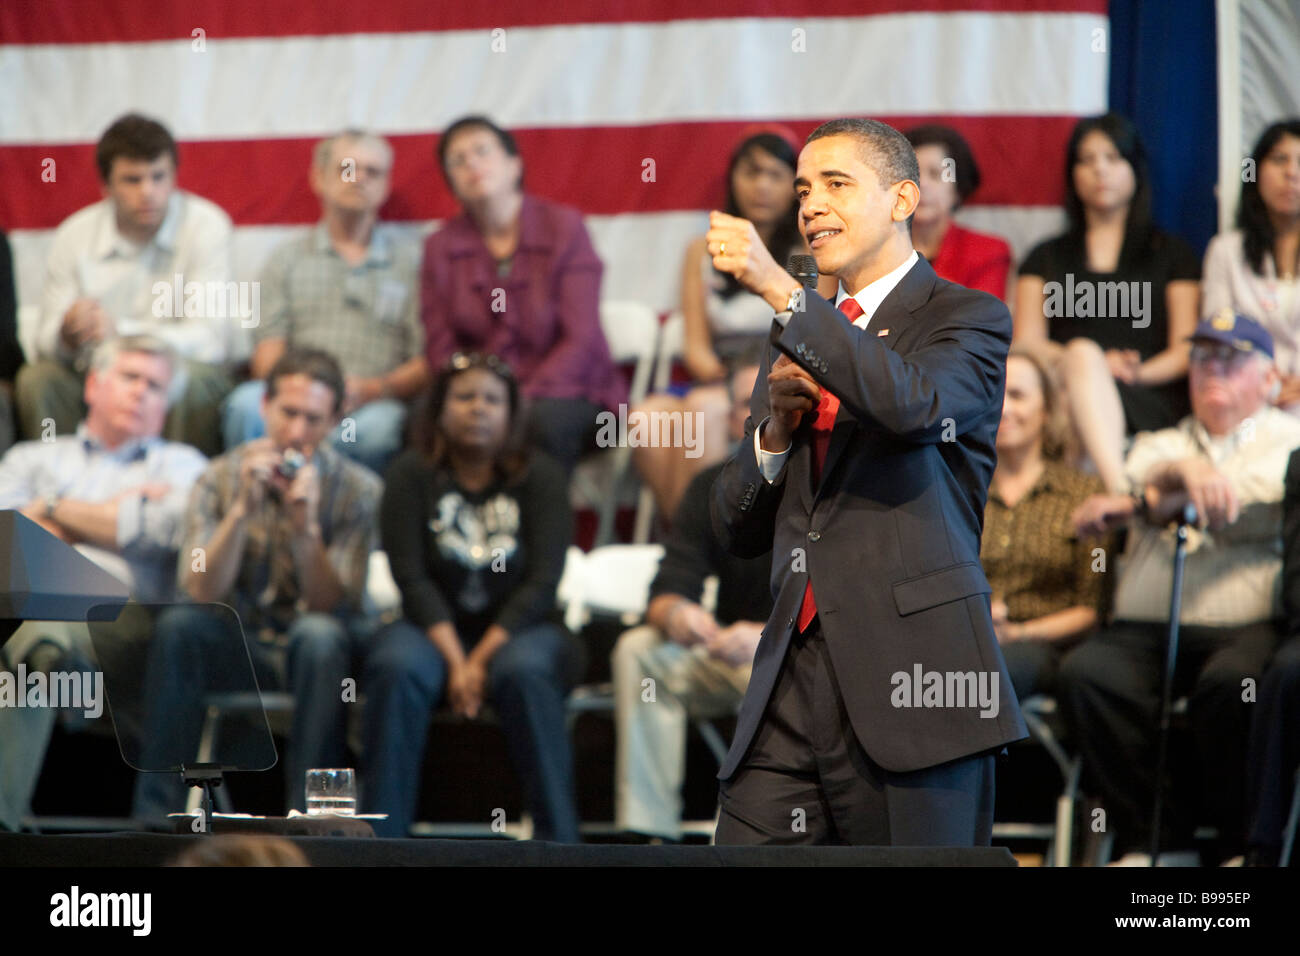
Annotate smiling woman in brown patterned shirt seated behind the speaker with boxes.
[980,346,1117,700]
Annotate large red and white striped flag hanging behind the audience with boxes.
[0,0,1110,351]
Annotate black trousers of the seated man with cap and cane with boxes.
[1057,622,1278,857]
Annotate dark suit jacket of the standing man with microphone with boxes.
[712,258,1026,780]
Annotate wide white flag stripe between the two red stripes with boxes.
[0,13,1108,143]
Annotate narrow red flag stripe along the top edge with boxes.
[0,0,1108,43]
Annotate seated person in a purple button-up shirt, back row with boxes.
[420,116,627,472]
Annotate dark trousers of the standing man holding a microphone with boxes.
[715,619,993,847]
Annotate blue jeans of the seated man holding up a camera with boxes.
[131,605,371,819]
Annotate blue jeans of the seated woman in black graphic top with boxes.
[360,620,581,843]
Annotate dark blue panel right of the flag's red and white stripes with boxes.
[1109,0,1218,254]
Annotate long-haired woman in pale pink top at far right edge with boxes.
[1201,117,1300,414]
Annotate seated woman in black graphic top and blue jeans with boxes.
[361,352,584,843]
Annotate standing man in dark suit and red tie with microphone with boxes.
[707,120,1026,845]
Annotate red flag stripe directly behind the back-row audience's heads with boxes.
[0,116,1076,229]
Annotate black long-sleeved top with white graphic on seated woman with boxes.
[380,451,573,645]
